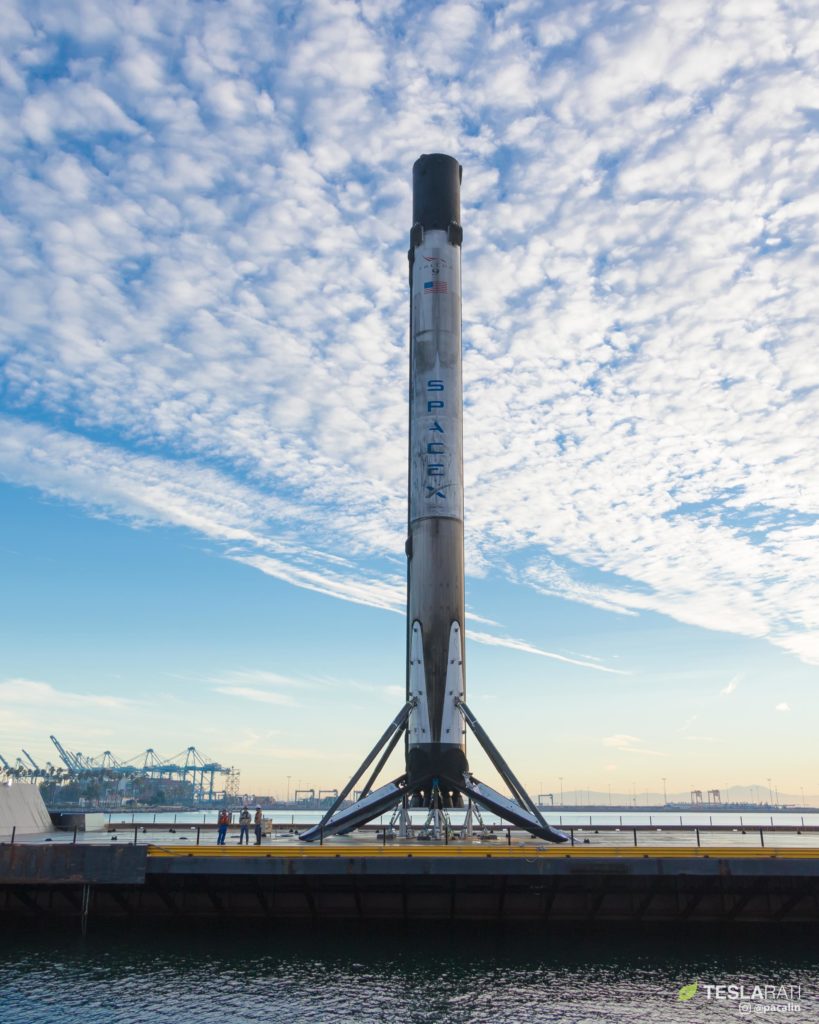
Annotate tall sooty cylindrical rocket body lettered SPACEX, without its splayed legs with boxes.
[406,154,468,806]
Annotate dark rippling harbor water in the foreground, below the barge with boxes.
[0,922,819,1024]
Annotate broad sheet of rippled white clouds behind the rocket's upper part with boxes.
[0,0,819,663]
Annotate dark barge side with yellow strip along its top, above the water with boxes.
[0,841,819,930]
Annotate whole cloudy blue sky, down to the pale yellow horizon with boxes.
[0,0,819,795]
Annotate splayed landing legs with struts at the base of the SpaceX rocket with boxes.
[299,700,568,843]
